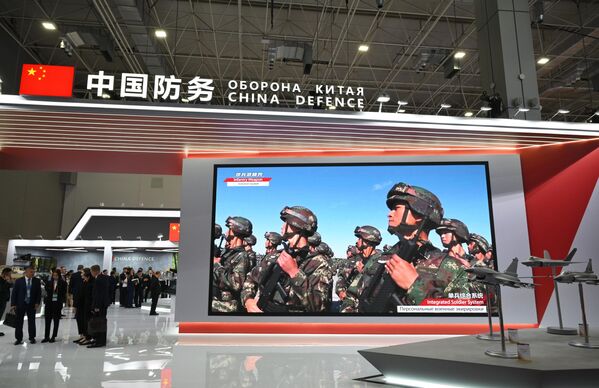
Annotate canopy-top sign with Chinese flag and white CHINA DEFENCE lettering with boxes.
[20,65,364,110]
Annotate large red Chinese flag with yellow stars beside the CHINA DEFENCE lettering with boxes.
[19,64,75,97]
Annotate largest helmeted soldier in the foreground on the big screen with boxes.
[360,183,478,312]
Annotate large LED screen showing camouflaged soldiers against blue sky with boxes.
[209,162,496,316]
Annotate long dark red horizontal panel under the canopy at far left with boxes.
[0,148,183,175]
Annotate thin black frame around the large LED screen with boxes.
[207,160,498,318]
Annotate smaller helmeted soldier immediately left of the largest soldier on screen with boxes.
[335,225,383,313]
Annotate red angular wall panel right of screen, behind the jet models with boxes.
[521,141,599,322]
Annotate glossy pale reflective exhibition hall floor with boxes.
[0,299,452,388]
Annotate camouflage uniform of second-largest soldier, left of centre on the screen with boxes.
[241,253,333,313]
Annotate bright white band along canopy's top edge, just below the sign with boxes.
[0,95,593,134]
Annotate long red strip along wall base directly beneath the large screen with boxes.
[179,322,538,334]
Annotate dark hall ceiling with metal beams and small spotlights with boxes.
[0,0,599,122]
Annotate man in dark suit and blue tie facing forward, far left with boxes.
[10,266,42,345]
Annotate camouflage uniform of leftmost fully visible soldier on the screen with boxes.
[212,247,250,313]
